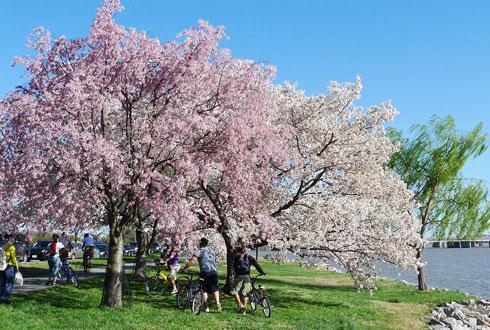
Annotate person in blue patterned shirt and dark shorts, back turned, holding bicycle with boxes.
[182,237,221,313]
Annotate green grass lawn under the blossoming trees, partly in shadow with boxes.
[0,260,468,330]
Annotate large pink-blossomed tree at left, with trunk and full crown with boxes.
[0,0,286,307]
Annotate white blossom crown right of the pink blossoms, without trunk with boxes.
[268,78,421,290]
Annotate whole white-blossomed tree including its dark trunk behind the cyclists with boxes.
[191,79,421,290]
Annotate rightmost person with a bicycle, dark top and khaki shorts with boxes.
[232,246,266,315]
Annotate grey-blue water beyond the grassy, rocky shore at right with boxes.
[379,248,490,299]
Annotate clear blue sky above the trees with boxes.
[0,0,490,183]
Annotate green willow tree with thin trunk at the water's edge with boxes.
[388,116,490,290]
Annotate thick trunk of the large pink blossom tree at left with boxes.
[101,219,124,307]
